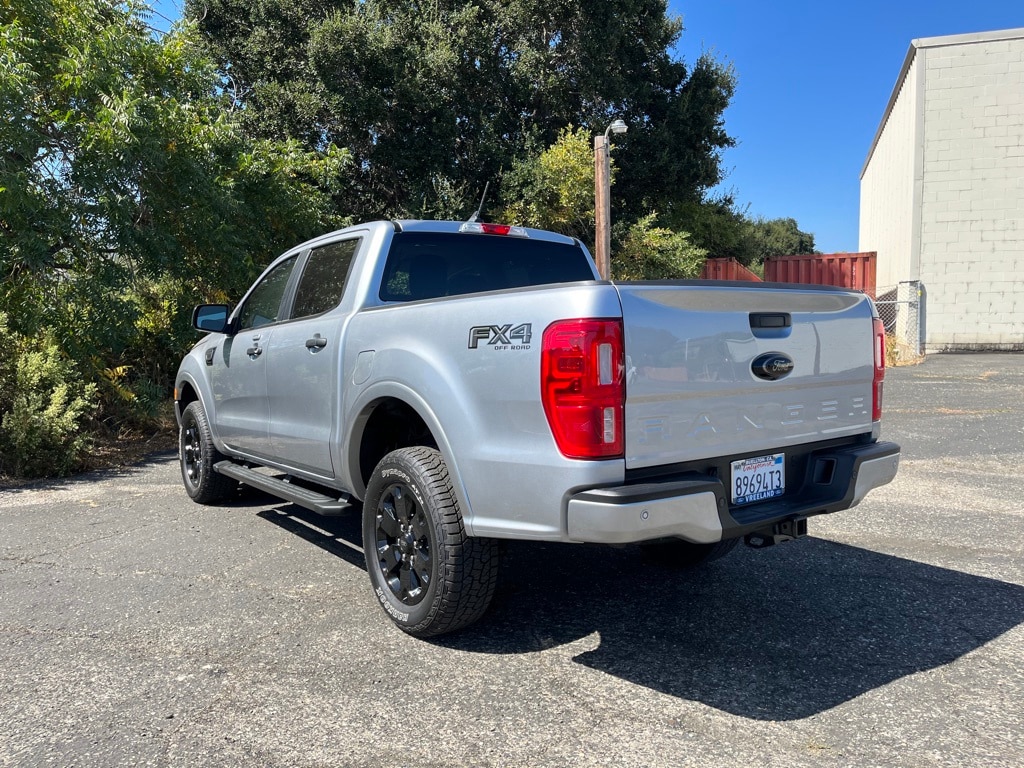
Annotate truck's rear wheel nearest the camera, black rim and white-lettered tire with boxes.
[362,447,498,637]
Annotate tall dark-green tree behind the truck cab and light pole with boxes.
[186,0,733,219]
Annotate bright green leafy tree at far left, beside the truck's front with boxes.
[0,0,348,475]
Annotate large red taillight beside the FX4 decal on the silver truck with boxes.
[541,318,626,459]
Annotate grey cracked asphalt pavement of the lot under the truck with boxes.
[0,354,1024,768]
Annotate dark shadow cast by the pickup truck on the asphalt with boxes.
[260,507,1024,721]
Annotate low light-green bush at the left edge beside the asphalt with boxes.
[0,314,96,477]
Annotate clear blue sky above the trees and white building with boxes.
[154,0,1024,253]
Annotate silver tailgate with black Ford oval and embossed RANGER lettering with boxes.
[615,283,873,469]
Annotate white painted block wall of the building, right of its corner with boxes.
[921,38,1024,351]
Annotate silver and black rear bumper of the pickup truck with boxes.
[568,442,900,544]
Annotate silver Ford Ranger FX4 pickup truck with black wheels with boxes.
[174,221,899,636]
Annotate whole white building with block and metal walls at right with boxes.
[860,29,1024,352]
